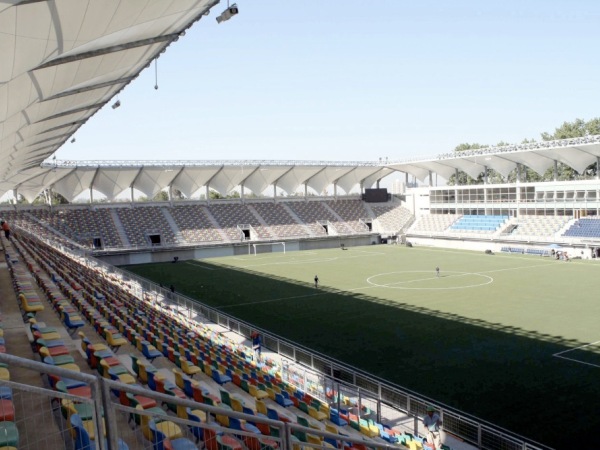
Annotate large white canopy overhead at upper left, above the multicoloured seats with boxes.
[0,0,219,193]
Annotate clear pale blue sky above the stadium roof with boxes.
[56,0,600,165]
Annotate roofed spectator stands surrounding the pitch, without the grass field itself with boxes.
[0,0,600,450]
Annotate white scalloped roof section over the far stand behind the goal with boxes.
[11,161,393,202]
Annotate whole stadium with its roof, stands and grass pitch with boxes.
[0,0,600,450]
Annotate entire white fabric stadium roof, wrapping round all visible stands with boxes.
[0,0,600,201]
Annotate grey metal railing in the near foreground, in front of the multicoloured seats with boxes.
[0,354,408,450]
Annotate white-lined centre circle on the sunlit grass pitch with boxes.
[367,270,494,291]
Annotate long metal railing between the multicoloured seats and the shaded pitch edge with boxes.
[81,258,549,450]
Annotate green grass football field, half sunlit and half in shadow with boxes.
[126,245,600,449]
